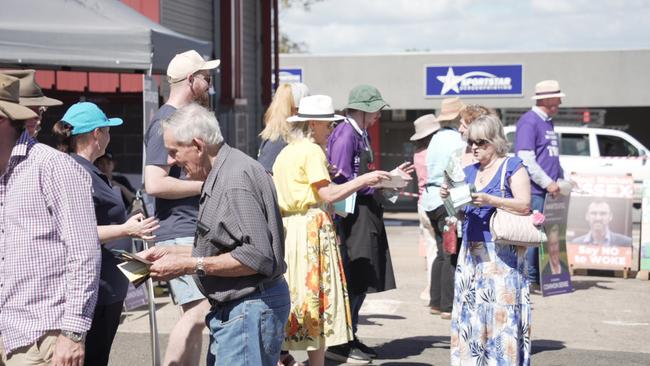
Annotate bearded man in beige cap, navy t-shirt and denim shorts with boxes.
[144,50,219,366]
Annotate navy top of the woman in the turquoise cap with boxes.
[70,154,131,305]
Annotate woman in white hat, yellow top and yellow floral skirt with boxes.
[273,95,389,366]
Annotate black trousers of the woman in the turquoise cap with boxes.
[84,301,123,366]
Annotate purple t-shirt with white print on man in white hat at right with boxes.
[515,110,564,194]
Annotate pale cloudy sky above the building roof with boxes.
[280,0,650,54]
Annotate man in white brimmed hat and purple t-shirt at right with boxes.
[515,80,565,285]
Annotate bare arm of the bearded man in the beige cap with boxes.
[144,165,203,200]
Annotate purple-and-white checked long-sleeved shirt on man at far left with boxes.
[0,132,101,354]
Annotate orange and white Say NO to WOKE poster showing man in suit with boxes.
[566,174,634,270]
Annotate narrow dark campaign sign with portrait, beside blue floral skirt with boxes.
[539,195,573,296]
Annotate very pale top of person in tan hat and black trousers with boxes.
[421,128,466,211]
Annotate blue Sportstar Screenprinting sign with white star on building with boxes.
[425,65,523,98]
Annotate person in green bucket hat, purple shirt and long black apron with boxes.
[325,85,395,362]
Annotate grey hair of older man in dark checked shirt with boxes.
[162,103,223,146]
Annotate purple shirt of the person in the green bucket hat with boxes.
[327,120,374,195]
